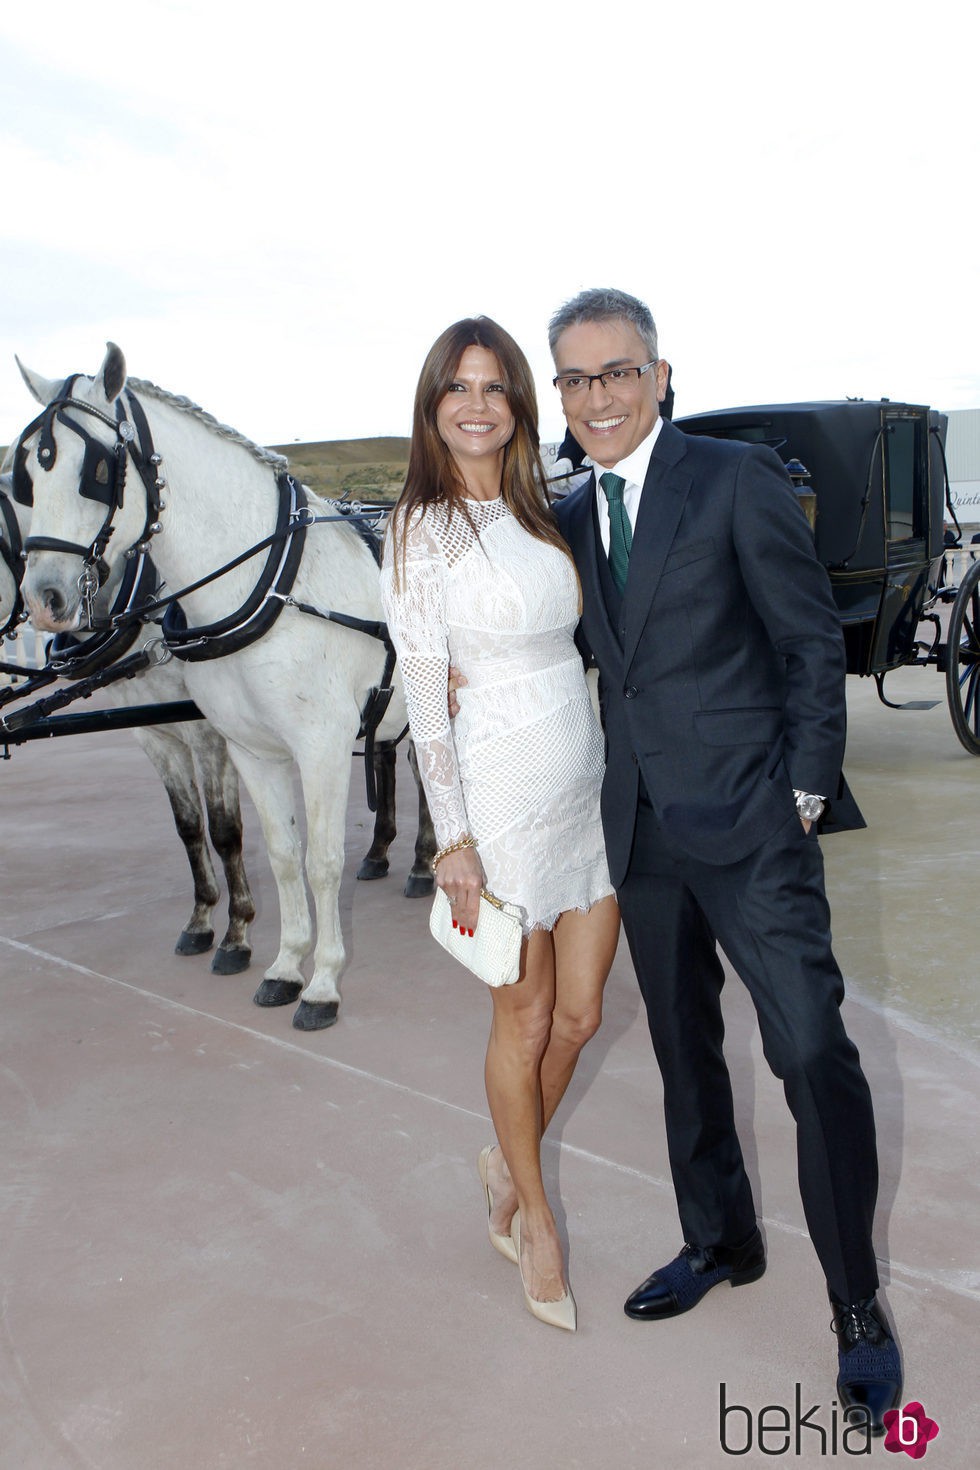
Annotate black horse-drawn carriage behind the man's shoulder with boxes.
[677,400,980,756]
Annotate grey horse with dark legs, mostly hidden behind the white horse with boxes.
[0,473,256,975]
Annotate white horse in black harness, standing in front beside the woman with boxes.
[19,344,429,1030]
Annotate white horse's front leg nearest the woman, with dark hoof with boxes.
[292,752,353,1030]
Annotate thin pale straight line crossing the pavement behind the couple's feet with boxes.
[7,935,980,1301]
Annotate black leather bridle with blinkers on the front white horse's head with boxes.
[13,373,166,628]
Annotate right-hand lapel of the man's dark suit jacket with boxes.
[623,420,691,669]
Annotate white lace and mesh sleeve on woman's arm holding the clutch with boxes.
[381,516,469,847]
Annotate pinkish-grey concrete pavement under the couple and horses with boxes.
[0,658,980,1470]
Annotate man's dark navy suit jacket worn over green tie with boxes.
[557,422,864,883]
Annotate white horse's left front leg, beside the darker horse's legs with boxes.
[229,745,313,1005]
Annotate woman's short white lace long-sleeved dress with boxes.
[382,498,613,932]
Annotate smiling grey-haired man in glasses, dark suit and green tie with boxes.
[550,280,901,1433]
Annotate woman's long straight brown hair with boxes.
[391,316,572,576]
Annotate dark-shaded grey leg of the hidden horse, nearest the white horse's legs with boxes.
[194,725,256,975]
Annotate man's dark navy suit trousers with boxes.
[619,792,877,1302]
